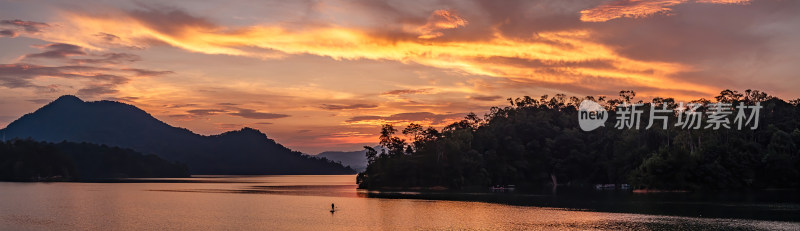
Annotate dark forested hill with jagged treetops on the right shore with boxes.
[357,90,800,190]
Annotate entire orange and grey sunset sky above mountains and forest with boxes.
[0,0,800,154]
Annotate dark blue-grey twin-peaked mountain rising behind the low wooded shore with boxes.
[0,95,354,174]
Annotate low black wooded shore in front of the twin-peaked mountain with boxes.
[0,139,189,181]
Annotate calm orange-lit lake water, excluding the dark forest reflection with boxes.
[0,175,800,230]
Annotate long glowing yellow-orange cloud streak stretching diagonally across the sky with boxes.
[32,7,717,98]
